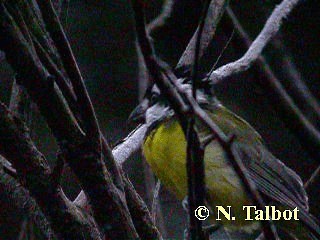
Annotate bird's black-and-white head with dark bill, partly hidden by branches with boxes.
[129,78,217,126]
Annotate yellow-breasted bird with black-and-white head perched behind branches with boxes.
[129,78,320,240]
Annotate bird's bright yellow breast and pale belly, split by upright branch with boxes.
[143,119,258,230]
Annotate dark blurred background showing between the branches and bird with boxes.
[0,0,320,240]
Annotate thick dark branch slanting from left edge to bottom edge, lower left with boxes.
[0,103,100,240]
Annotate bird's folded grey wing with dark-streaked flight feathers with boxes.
[239,144,308,211]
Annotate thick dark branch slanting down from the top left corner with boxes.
[0,1,82,141]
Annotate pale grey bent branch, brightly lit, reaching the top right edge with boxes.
[210,0,300,83]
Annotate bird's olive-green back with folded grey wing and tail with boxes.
[202,104,320,239]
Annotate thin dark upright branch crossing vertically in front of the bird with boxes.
[182,0,215,239]
